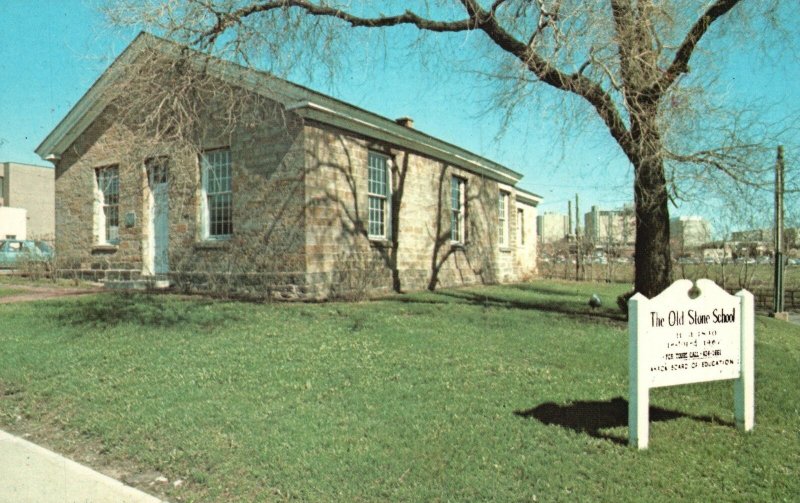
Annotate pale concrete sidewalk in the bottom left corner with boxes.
[0,431,163,503]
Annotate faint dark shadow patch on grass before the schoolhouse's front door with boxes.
[56,292,224,328]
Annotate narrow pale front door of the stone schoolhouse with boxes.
[148,160,169,274]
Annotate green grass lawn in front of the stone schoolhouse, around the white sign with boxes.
[0,281,800,502]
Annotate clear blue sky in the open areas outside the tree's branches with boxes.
[0,0,800,230]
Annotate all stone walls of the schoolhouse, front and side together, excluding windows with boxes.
[56,79,536,299]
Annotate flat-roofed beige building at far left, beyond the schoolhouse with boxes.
[0,162,55,239]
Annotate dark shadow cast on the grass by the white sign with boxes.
[514,397,734,445]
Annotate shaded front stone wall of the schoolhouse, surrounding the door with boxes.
[56,90,307,296]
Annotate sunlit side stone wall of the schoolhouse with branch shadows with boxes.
[305,123,536,295]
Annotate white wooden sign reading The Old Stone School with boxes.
[628,279,754,449]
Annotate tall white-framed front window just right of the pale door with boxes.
[200,148,233,240]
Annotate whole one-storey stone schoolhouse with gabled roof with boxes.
[37,33,541,299]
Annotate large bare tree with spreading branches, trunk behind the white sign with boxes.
[101,0,797,296]
